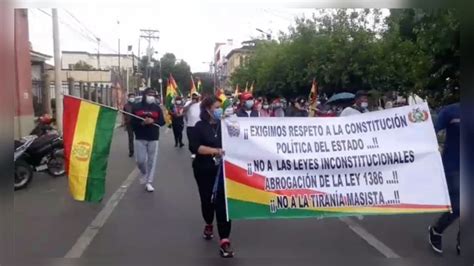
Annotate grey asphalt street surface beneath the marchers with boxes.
[15,128,458,265]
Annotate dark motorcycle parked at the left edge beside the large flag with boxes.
[15,114,65,190]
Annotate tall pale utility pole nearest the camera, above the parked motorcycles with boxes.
[52,8,63,132]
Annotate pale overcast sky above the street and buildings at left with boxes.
[29,5,320,72]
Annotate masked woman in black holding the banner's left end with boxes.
[191,96,234,258]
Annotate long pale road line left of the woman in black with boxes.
[64,168,138,259]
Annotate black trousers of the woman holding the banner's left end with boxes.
[193,166,231,239]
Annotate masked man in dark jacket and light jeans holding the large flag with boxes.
[132,88,165,192]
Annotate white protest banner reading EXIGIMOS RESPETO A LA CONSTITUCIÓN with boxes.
[221,103,451,219]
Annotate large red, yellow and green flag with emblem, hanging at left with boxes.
[63,95,117,202]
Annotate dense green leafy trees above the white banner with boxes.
[231,9,460,106]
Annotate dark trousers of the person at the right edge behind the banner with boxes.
[434,173,460,235]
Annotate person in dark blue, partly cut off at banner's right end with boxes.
[429,103,461,254]
